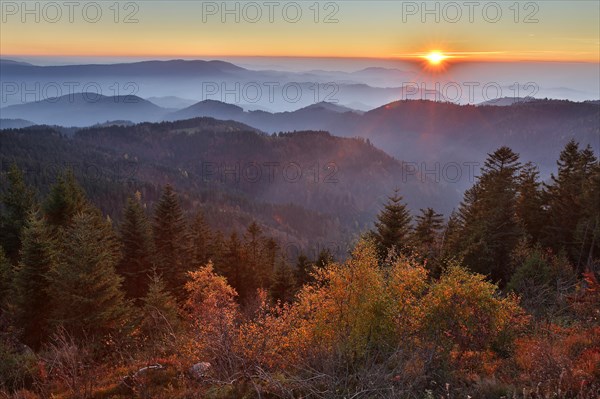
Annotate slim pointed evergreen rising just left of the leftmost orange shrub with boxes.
[153,185,188,297]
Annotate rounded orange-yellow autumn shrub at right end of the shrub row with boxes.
[421,264,527,382]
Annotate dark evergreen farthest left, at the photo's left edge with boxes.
[0,163,35,264]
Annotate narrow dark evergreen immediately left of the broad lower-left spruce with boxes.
[12,212,57,348]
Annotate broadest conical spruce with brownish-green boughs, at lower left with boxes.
[48,212,127,336]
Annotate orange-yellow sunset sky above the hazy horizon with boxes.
[0,0,600,63]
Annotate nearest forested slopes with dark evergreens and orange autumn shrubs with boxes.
[0,119,600,398]
